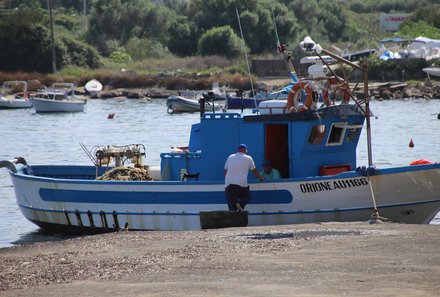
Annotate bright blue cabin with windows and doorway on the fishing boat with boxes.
[161,104,365,181]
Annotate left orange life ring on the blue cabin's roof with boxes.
[287,81,319,113]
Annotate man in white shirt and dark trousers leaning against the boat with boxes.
[225,144,263,211]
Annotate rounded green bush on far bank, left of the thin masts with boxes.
[198,26,242,58]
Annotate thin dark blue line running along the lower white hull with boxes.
[18,200,440,216]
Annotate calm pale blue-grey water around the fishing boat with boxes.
[0,99,440,247]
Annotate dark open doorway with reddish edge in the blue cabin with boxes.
[264,124,290,178]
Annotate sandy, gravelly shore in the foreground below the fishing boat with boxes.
[0,222,440,297]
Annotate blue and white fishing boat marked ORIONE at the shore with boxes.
[0,38,440,233]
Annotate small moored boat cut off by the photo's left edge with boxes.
[0,80,32,108]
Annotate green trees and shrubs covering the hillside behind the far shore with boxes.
[0,0,440,76]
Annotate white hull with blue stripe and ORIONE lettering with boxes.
[11,164,440,232]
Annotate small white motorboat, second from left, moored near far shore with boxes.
[30,83,87,113]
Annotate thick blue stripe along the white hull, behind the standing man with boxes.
[39,188,293,205]
